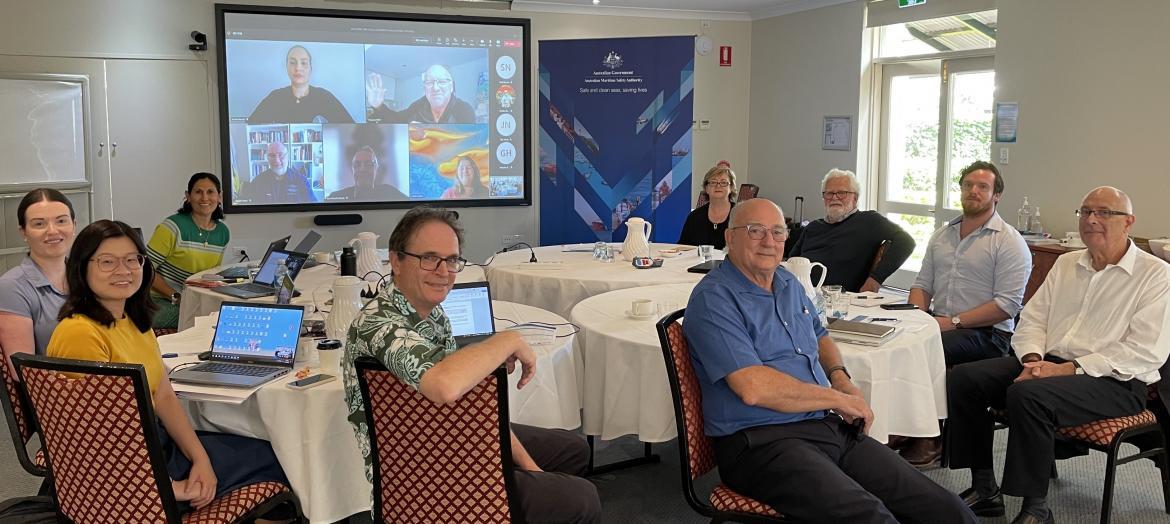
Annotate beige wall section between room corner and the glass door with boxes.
[748,1,865,218]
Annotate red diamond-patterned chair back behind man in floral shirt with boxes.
[355,357,521,523]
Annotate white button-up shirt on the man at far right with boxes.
[1012,242,1170,384]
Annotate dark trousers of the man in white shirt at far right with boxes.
[947,357,1145,497]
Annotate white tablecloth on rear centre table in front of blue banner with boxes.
[487,243,706,318]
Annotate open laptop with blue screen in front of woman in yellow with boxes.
[171,302,304,387]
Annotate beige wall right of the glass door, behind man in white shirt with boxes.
[993,0,1170,236]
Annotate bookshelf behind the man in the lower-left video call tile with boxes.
[248,124,323,191]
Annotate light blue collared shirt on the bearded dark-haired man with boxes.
[913,212,1032,332]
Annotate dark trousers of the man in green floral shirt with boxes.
[511,423,601,524]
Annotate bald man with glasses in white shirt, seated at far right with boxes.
[947,187,1170,524]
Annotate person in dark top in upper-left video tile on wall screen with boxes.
[248,46,353,124]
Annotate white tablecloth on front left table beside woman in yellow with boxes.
[159,301,581,522]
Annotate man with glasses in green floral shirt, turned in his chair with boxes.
[342,206,601,523]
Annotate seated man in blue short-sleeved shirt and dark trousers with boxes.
[682,199,977,524]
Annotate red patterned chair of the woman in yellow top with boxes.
[13,354,301,524]
